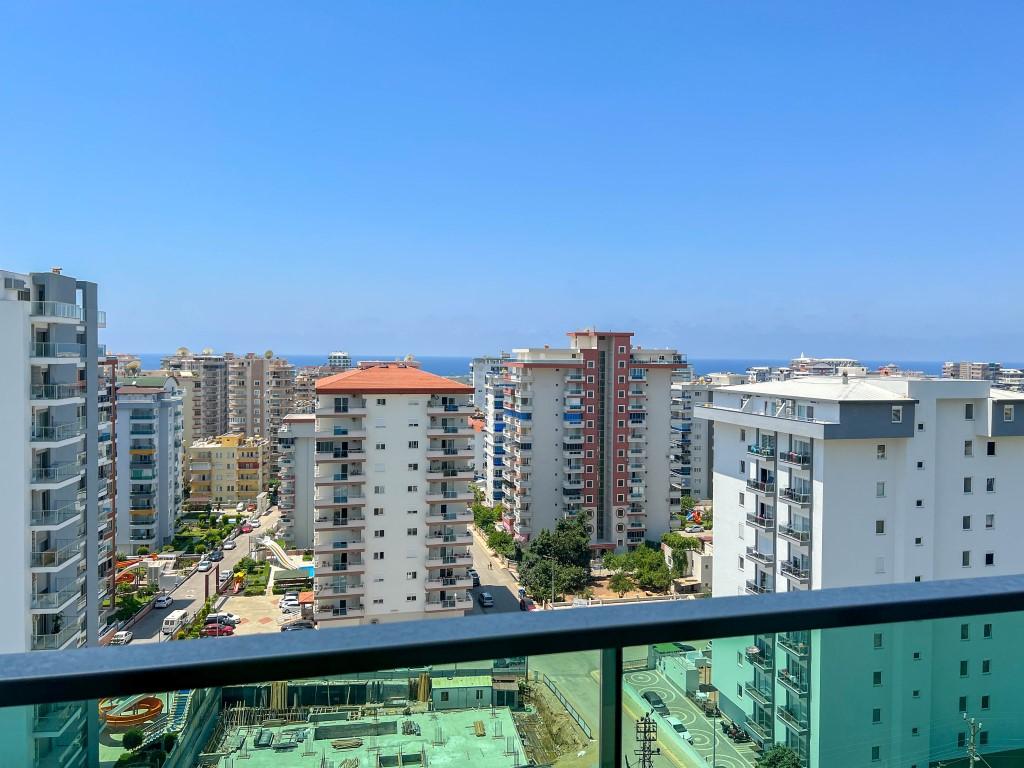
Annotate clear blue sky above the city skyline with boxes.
[0,0,1024,359]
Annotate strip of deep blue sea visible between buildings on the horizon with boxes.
[132,352,970,376]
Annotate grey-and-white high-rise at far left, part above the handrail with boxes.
[0,269,116,655]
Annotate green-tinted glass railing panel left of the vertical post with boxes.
[0,655,601,768]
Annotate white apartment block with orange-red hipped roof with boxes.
[311,360,474,627]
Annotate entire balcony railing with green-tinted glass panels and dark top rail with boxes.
[0,575,1024,768]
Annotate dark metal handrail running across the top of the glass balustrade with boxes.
[6,574,1024,706]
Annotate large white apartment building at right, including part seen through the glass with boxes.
[696,377,1024,768]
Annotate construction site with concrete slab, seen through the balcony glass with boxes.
[194,667,593,768]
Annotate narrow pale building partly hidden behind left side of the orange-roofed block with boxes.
[278,414,316,550]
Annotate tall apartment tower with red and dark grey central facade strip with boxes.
[485,330,685,550]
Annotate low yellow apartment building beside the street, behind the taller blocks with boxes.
[188,434,270,508]
